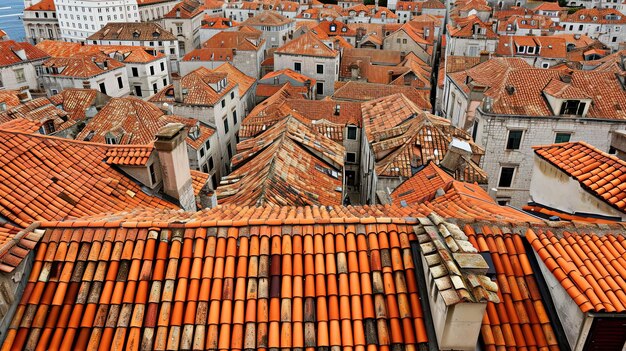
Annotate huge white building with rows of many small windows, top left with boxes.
[54,0,140,42]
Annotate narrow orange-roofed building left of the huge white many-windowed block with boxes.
[22,0,61,44]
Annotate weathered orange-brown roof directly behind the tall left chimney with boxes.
[76,97,215,148]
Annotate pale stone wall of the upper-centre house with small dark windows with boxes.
[274,52,339,97]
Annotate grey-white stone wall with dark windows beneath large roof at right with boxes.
[476,109,626,207]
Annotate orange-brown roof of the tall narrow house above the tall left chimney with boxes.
[149,63,237,106]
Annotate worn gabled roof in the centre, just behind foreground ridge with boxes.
[217,117,345,206]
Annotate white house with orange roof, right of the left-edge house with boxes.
[42,53,130,97]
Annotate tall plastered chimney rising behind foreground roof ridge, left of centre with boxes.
[154,123,196,211]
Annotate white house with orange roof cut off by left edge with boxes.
[0,40,50,90]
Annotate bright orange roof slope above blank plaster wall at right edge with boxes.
[533,141,626,212]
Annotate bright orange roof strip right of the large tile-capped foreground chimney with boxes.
[463,224,559,351]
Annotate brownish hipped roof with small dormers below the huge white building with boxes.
[87,22,177,41]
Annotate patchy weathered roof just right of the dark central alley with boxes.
[361,94,487,184]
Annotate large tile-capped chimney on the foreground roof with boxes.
[415,212,500,351]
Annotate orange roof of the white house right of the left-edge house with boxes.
[43,53,124,78]
